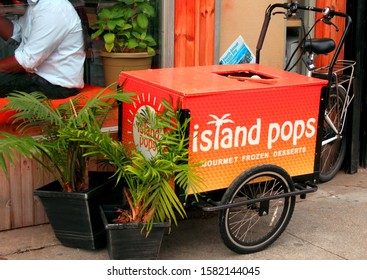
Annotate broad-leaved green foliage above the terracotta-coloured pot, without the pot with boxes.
[91,0,157,55]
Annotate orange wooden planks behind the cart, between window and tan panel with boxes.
[174,0,215,67]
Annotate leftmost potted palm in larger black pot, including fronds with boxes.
[0,89,135,249]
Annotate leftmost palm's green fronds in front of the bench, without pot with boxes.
[0,91,132,192]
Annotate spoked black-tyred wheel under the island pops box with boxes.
[219,165,296,254]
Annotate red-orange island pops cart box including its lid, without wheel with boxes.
[120,64,326,194]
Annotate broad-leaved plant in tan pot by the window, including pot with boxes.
[91,0,157,85]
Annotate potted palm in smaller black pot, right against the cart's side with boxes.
[62,98,202,259]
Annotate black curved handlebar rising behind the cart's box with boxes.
[256,2,352,79]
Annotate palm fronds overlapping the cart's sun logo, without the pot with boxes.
[61,98,203,233]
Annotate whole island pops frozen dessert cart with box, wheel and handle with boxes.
[120,1,354,253]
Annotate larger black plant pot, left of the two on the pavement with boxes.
[34,172,122,250]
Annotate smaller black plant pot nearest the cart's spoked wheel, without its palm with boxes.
[100,205,170,260]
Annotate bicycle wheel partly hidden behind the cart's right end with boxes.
[320,85,347,182]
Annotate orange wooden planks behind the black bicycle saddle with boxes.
[315,0,347,67]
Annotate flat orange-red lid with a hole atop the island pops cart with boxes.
[119,64,327,96]
